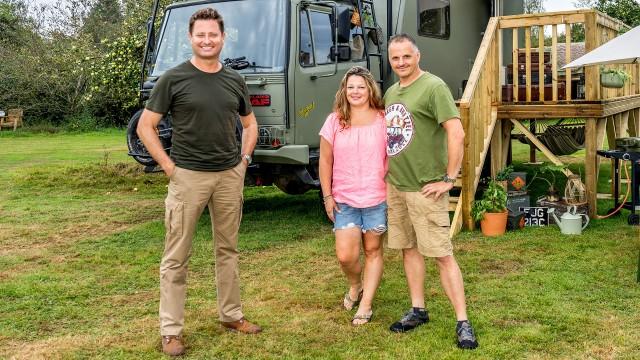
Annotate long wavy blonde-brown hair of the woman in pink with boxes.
[333,66,384,129]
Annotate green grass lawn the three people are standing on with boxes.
[0,130,640,359]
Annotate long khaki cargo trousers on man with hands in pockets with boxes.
[160,161,246,335]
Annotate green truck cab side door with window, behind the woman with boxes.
[290,4,366,153]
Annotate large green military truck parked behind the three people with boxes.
[127,0,523,194]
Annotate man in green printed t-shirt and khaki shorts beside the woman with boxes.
[384,34,478,349]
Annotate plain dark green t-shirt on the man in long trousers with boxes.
[146,61,252,171]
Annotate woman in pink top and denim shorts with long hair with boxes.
[320,66,387,325]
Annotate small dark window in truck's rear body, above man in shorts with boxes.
[418,0,451,39]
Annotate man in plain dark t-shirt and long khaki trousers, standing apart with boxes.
[138,8,261,356]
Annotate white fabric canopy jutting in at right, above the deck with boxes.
[562,26,640,69]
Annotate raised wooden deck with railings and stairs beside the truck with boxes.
[451,10,640,234]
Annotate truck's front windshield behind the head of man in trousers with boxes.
[151,0,287,76]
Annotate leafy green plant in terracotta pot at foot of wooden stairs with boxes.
[471,179,508,236]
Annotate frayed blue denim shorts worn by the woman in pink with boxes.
[333,201,387,233]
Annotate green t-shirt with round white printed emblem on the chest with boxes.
[384,73,460,191]
